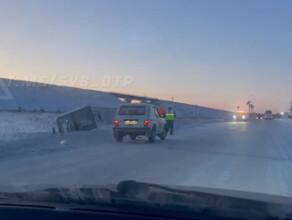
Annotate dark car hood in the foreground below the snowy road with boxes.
[0,181,292,217]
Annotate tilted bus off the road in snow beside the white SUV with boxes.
[57,106,116,134]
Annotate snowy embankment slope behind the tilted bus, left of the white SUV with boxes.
[0,79,121,112]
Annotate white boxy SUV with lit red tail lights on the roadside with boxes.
[113,103,167,143]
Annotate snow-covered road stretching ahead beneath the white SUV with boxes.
[0,119,292,196]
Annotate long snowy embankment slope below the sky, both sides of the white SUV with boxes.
[0,78,232,119]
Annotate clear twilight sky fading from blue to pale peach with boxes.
[0,0,292,111]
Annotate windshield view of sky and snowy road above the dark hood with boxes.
[0,0,292,217]
